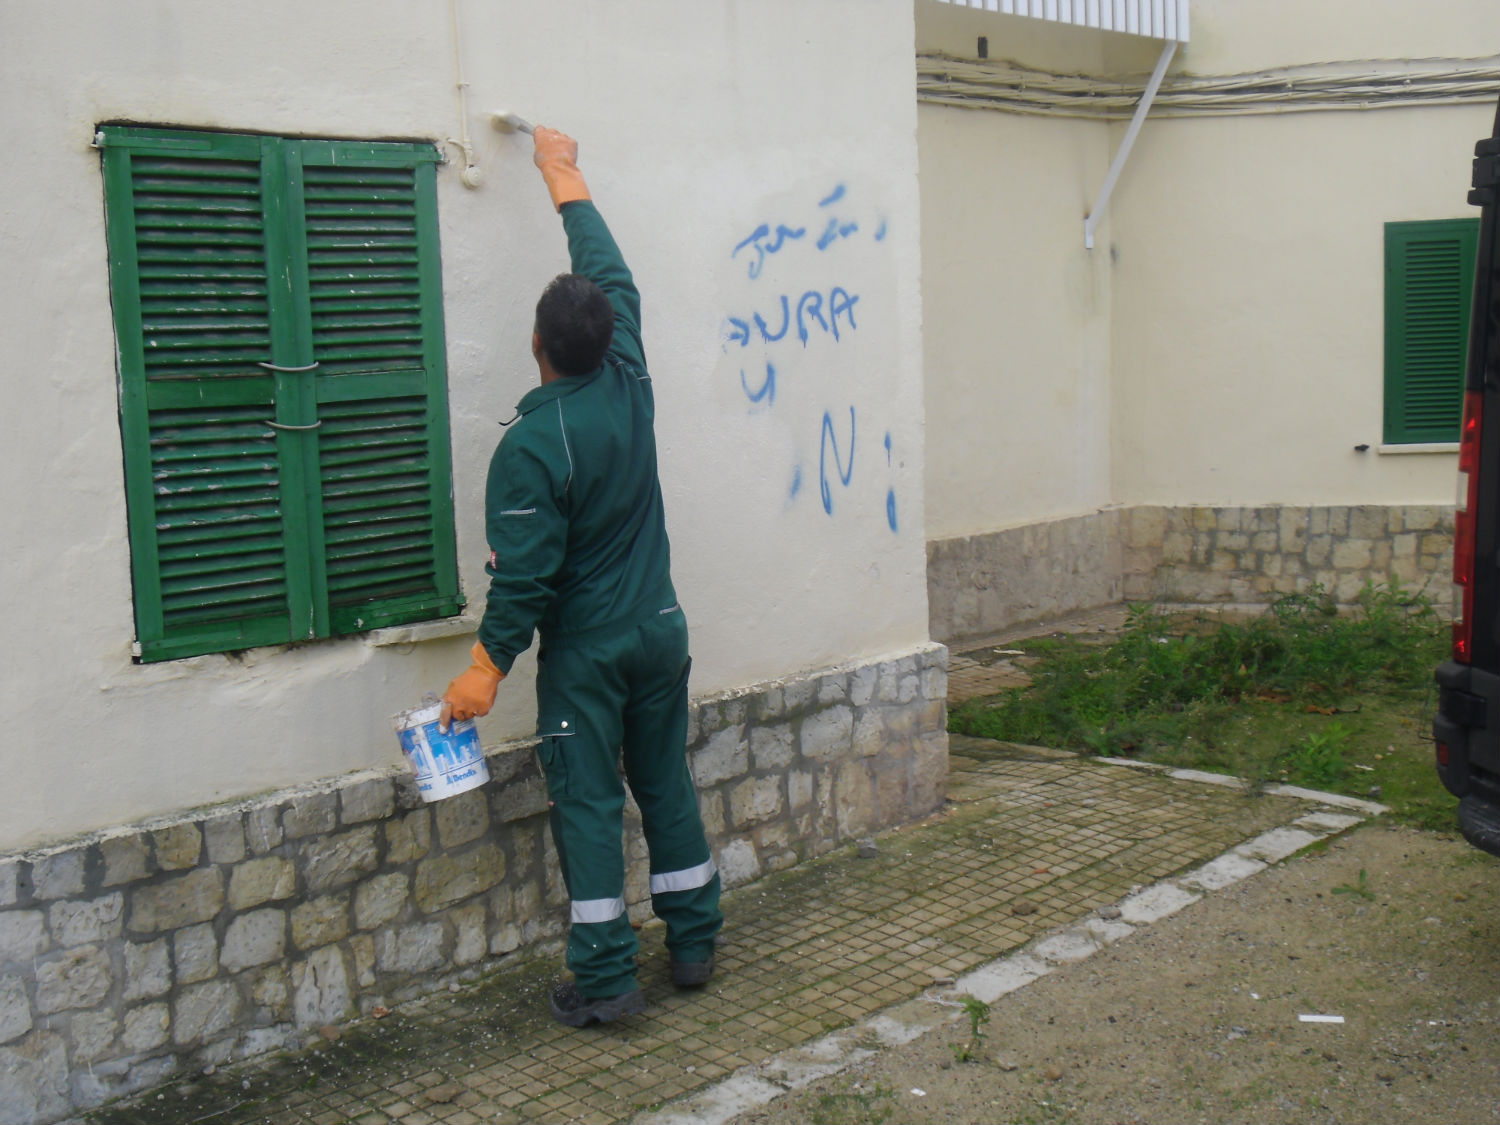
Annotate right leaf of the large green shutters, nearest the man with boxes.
[292,141,462,633]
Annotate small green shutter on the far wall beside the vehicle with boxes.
[1385,219,1479,446]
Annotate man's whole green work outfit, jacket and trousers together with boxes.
[479,201,723,998]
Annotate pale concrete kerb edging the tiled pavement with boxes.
[632,759,1388,1125]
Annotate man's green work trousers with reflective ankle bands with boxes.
[537,611,722,998]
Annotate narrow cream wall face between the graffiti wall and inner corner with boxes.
[917,0,1110,539]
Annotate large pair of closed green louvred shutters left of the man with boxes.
[101,128,461,660]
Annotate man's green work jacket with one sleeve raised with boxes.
[479,201,677,672]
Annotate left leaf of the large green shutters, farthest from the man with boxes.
[104,131,298,660]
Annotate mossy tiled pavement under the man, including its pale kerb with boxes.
[84,737,1358,1125]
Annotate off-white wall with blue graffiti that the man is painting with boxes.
[0,0,927,848]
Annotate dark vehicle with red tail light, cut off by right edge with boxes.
[1433,101,1500,855]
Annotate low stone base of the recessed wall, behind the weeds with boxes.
[927,506,1454,642]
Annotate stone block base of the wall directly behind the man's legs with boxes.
[0,645,948,1125]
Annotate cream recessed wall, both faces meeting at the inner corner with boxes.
[917,0,1500,539]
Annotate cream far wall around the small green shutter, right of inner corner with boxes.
[1110,0,1500,506]
